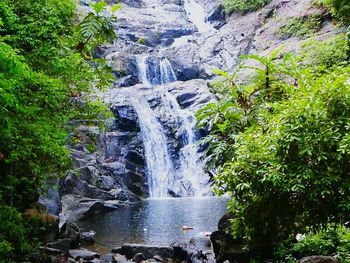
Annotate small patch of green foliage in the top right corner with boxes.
[318,0,350,25]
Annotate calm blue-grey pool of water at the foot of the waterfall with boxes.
[78,197,227,247]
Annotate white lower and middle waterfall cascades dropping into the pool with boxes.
[127,56,209,197]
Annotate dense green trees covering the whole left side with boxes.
[0,0,120,262]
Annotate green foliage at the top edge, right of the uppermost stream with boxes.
[224,0,271,14]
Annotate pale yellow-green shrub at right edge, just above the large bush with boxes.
[302,34,350,67]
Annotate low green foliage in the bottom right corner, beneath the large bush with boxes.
[274,226,350,263]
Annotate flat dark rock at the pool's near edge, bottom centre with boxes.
[114,244,174,259]
